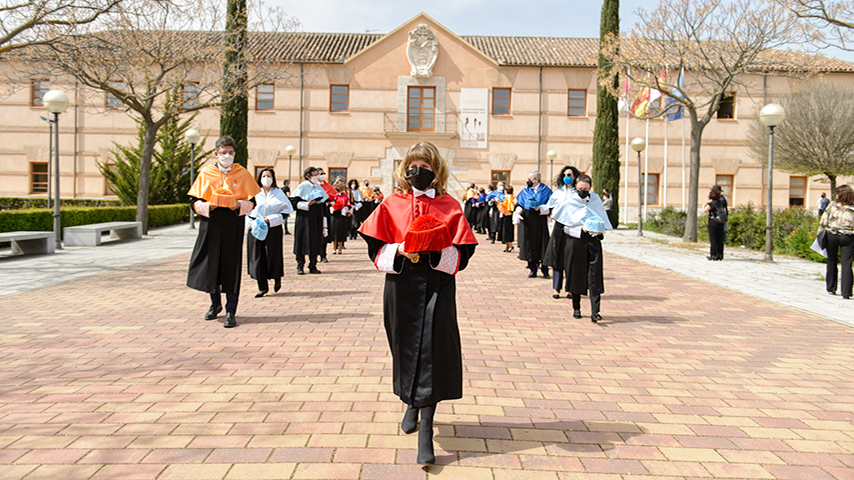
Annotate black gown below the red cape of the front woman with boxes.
[361,238,475,407]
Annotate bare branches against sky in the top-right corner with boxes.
[777,0,854,51]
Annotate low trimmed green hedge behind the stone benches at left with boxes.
[0,203,190,238]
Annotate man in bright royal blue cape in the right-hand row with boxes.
[513,171,552,278]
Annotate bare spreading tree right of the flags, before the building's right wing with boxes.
[600,0,812,242]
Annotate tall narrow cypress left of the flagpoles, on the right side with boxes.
[591,0,620,226]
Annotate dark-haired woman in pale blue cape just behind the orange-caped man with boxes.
[246,167,294,298]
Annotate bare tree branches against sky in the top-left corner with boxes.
[0,0,122,54]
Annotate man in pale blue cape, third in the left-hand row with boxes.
[291,167,328,275]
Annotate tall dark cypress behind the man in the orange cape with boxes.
[219,0,249,167]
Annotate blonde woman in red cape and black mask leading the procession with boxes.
[359,142,477,464]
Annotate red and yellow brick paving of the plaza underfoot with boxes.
[0,235,854,480]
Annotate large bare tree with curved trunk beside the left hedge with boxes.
[17,0,297,232]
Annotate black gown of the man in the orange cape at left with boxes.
[187,197,247,293]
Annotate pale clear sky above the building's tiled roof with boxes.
[272,0,854,61]
